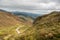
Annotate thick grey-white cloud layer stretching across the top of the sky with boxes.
[0,0,60,10]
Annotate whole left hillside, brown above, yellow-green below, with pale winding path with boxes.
[0,10,32,40]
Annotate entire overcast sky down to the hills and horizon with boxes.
[0,0,60,14]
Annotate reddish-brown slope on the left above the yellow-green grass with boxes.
[0,11,23,27]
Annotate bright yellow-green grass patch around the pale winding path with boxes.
[0,25,29,40]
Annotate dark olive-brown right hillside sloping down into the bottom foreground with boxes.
[10,11,60,40]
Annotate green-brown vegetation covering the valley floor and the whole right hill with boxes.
[0,12,60,40]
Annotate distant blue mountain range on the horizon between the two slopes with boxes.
[12,11,42,19]
